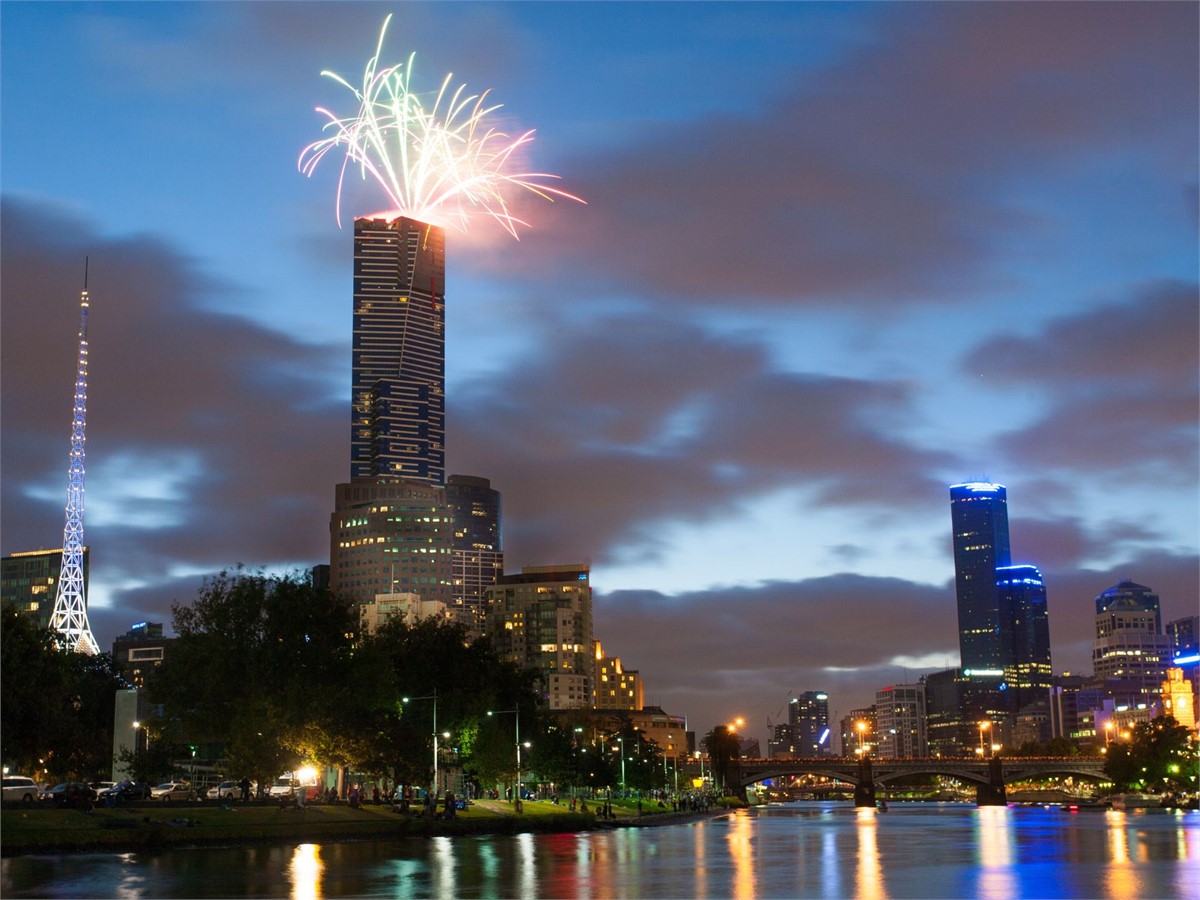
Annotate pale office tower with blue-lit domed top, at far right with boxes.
[1092,581,1171,702]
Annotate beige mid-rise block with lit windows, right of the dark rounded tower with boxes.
[487,565,595,709]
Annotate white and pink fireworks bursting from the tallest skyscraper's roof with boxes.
[299,16,583,238]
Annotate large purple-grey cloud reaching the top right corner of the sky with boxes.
[520,4,1198,308]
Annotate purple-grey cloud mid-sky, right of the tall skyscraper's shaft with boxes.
[446,314,948,564]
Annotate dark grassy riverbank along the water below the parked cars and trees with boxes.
[0,800,720,857]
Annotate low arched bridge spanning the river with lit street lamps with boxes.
[725,756,1106,806]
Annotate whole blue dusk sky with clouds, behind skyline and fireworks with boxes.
[0,2,1200,738]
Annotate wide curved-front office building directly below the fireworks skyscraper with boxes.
[329,478,454,608]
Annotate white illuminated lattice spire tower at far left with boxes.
[50,260,100,655]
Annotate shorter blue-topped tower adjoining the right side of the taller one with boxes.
[996,565,1054,713]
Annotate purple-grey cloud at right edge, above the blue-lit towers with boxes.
[961,282,1200,485]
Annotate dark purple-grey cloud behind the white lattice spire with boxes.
[2,198,347,628]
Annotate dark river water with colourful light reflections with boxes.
[0,803,1200,900]
